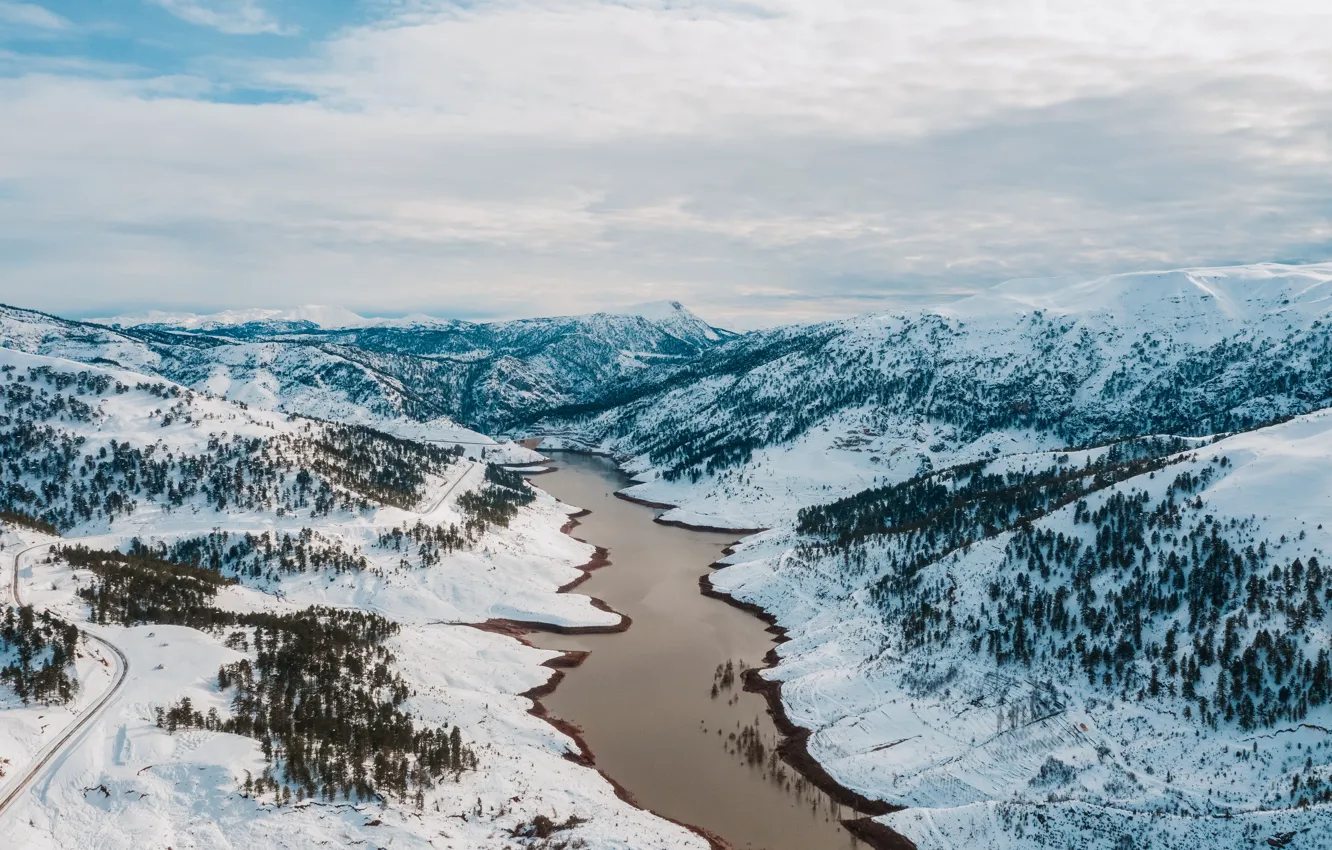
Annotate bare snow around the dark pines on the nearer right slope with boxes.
[713,412,1332,849]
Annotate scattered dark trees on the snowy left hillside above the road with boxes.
[0,366,461,530]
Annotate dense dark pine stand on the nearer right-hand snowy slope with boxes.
[972,457,1332,730]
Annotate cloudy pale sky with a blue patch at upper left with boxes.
[0,0,1332,329]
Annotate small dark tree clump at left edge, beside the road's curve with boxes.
[0,605,79,705]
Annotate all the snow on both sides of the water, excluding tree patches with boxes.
[15,264,1332,850]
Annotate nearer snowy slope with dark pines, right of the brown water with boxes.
[713,412,1332,849]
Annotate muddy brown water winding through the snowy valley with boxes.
[529,453,863,850]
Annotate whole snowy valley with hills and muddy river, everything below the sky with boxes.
[0,264,1332,850]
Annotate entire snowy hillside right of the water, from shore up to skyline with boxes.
[522,265,1332,850]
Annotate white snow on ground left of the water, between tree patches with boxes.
[0,349,707,850]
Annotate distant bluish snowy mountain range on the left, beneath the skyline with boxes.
[0,304,734,431]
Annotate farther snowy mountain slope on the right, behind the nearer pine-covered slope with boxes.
[530,264,1332,528]
